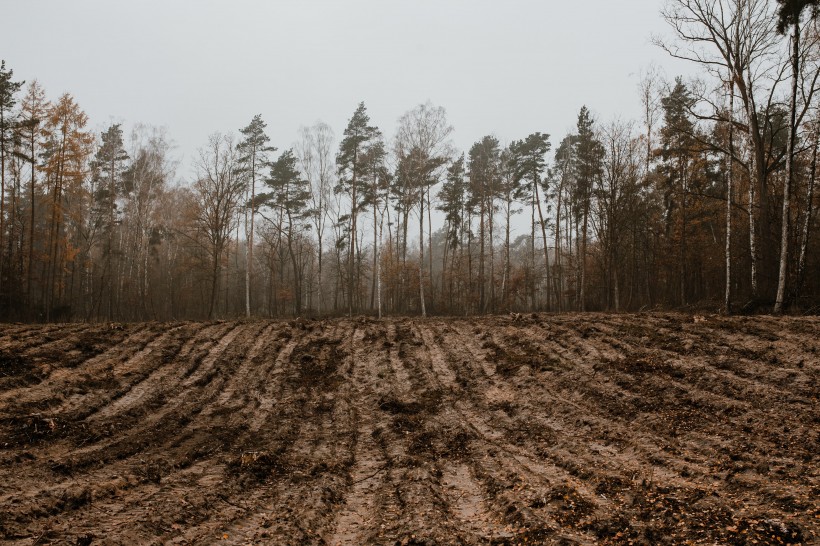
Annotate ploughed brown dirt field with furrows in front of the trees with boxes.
[0,314,820,545]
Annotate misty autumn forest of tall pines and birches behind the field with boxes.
[0,0,820,322]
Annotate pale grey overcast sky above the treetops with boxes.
[0,0,692,178]
